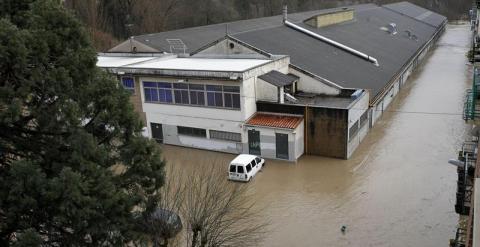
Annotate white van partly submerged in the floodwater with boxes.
[228,154,265,182]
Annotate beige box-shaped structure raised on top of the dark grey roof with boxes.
[304,8,354,28]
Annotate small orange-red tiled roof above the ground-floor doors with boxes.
[246,112,303,129]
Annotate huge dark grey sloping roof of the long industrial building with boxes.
[121,2,446,98]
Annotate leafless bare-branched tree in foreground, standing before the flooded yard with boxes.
[182,162,268,247]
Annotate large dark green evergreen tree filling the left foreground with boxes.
[0,0,164,246]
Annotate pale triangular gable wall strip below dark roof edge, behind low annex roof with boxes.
[288,68,340,95]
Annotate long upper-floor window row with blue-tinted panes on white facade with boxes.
[143,81,240,109]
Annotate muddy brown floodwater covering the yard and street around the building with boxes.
[164,25,471,247]
